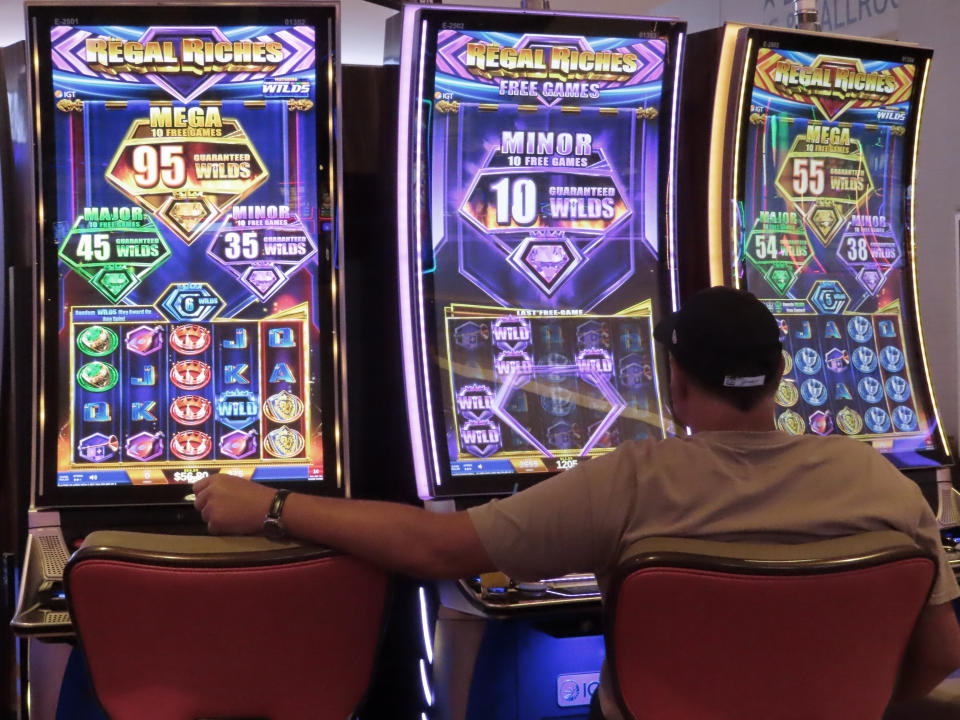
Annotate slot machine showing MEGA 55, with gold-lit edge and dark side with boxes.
[679,24,953,500]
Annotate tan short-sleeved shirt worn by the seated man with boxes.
[469,431,960,717]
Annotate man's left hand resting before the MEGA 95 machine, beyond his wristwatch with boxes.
[193,475,276,535]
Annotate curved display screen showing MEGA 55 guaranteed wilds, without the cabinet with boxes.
[738,41,936,465]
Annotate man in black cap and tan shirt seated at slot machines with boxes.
[195,287,960,720]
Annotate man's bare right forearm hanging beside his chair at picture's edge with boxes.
[893,603,960,702]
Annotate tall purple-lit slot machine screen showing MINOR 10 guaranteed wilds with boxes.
[401,11,682,496]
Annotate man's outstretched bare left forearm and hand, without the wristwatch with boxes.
[194,475,494,579]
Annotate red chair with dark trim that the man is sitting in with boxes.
[605,532,935,720]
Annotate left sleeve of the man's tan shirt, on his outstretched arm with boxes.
[468,443,637,580]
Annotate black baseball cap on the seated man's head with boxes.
[653,287,783,389]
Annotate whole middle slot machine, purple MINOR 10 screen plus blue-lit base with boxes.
[388,6,685,718]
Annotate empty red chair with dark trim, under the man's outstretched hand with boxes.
[64,532,387,720]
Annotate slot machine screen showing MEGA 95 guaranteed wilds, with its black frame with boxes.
[29,5,340,504]
